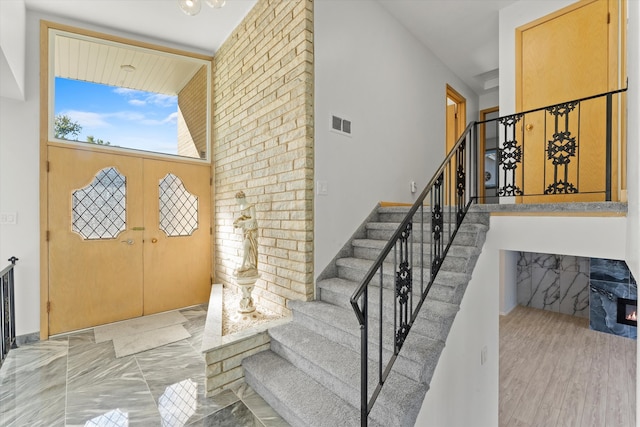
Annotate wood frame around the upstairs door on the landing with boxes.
[515,0,627,201]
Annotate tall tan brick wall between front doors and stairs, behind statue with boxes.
[213,0,313,314]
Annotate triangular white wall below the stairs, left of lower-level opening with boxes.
[416,234,500,427]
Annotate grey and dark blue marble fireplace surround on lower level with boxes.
[516,252,638,339]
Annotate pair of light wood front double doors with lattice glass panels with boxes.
[48,146,211,335]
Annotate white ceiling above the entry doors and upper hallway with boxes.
[24,0,517,95]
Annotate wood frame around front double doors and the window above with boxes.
[39,20,215,340]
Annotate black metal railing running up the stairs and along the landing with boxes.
[350,88,627,426]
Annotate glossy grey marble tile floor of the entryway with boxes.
[0,305,288,427]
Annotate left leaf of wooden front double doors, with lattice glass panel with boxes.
[48,147,143,335]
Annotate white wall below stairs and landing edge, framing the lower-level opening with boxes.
[416,216,626,427]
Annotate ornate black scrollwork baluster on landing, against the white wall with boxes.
[498,114,523,196]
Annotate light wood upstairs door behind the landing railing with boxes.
[516,0,618,203]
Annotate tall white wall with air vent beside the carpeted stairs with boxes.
[314,0,478,276]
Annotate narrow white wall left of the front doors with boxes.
[0,7,40,336]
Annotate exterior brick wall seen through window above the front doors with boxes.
[178,66,207,158]
